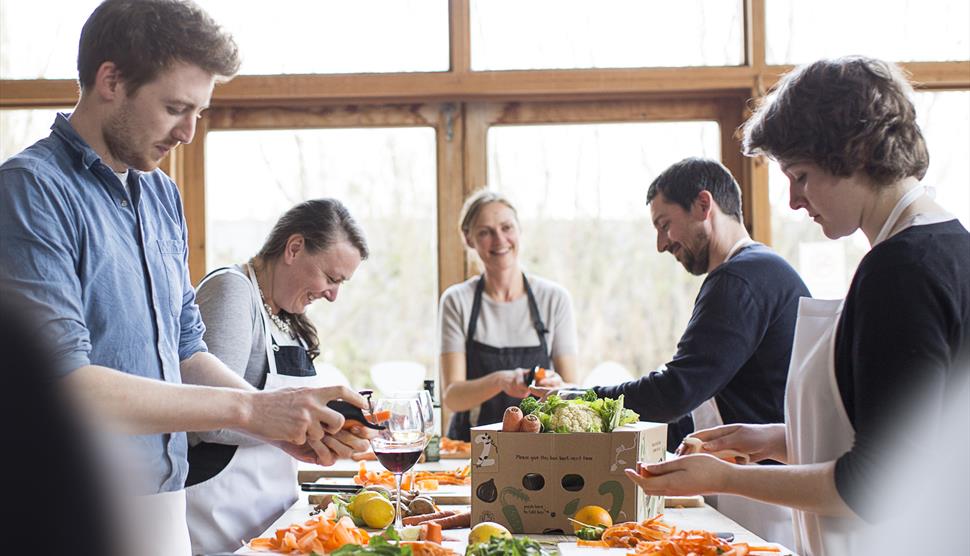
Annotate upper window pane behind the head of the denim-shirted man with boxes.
[0,0,448,79]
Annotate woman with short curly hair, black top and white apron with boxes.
[629,57,970,556]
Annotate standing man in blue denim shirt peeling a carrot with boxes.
[0,0,367,554]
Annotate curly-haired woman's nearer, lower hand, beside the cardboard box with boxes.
[624,454,737,496]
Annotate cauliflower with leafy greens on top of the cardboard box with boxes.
[519,390,640,433]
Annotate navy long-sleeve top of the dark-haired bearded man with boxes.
[595,244,810,449]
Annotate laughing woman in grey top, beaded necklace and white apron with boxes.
[185,199,368,554]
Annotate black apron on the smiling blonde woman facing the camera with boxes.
[448,273,552,442]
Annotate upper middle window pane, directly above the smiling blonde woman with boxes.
[471,0,744,70]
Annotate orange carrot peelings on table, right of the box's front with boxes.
[576,514,779,556]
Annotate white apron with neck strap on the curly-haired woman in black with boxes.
[785,185,925,556]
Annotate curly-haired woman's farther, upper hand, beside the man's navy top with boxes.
[675,424,788,463]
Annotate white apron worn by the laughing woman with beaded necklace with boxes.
[186,266,324,554]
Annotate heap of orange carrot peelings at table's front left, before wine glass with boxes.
[249,515,370,554]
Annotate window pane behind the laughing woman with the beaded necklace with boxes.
[206,128,437,387]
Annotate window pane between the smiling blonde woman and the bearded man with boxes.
[488,122,720,384]
